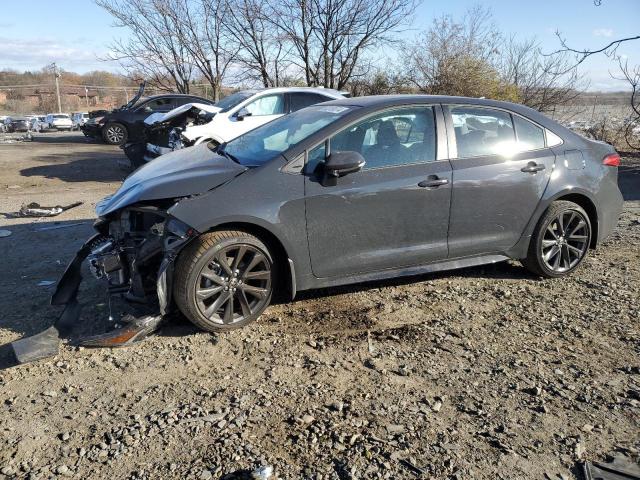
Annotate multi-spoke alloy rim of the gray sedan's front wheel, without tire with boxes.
[195,244,271,325]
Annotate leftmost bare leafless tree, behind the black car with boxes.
[96,0,194,93]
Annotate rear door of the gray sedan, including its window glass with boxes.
[445,105,555,258]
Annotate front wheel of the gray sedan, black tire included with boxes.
[173,230,276,332]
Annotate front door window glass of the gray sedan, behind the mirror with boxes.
[331,107,436,170]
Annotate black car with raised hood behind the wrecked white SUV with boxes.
[82,84,213,145]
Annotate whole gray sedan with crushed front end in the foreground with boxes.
[12,96,622,358]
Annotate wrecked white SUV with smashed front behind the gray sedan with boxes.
[122,87,346,168]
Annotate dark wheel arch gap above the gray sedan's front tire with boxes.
[203,221,296,300]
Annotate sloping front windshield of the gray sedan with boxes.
[223,105,353,167]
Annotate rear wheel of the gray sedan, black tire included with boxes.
[522,200,592,278]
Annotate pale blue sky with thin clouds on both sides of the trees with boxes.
[0,0,640,91]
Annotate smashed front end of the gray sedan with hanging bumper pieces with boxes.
[12,202,197,363]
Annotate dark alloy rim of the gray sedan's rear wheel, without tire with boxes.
[541,210,590,273]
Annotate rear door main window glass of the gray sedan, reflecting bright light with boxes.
[451,107,516,158]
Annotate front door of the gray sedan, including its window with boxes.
[305,106,451,277]
